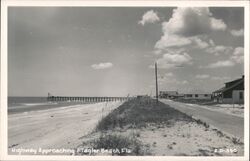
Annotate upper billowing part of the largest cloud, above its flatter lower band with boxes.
[162,7,227,37]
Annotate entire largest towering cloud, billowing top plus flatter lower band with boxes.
[155,7,227,50]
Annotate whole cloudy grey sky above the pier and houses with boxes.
[8,7,244,96]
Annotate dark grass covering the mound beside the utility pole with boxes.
[96,98,192,131]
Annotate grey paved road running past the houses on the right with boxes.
[161,99,244,139]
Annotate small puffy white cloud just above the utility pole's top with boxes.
[157,53,192,68]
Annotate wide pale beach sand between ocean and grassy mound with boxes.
[8,102,123,154]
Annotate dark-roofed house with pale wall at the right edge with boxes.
[212,75,244,104]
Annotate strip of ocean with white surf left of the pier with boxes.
[8,97,85,114]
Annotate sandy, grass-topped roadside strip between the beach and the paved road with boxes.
[76,99,244,156]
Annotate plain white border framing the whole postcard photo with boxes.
[0,0,249,161]
